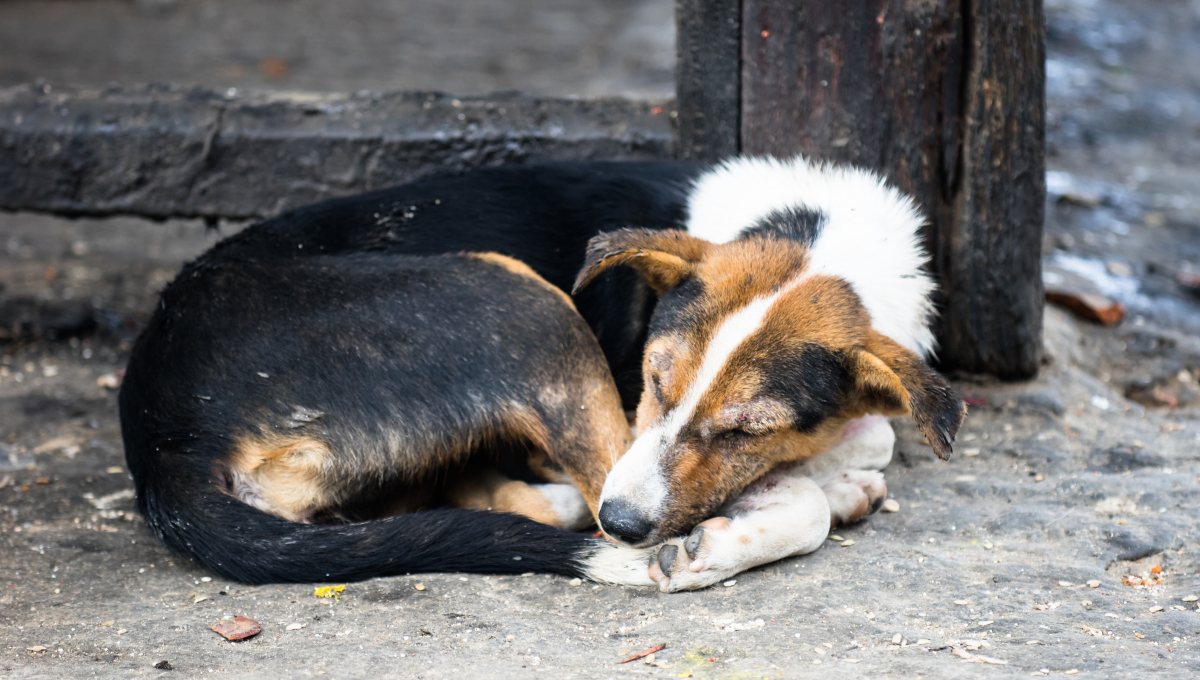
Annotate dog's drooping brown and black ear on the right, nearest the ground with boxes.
[850,331,966,461]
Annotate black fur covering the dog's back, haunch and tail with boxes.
[120,163,700,583]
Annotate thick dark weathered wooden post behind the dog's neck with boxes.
[677,0,1045,379]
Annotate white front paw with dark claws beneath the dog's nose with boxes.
[647,517,749,592]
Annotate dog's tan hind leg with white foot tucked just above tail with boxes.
[446,469,592,529]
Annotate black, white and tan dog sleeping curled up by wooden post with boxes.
[120,158,965,591]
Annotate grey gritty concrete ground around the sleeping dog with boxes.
[0,0,1200,679]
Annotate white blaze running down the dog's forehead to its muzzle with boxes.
[600,275,808,524]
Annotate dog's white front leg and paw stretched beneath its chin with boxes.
[648,469,830,592]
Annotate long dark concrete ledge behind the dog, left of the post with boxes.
[0,85,674,219]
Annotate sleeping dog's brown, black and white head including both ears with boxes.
[576,229,964,546]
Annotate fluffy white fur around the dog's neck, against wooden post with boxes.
[688,157,935,356]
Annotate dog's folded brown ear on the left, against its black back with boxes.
[571,229,713,296]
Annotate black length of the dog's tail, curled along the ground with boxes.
[138,479,600,584]
